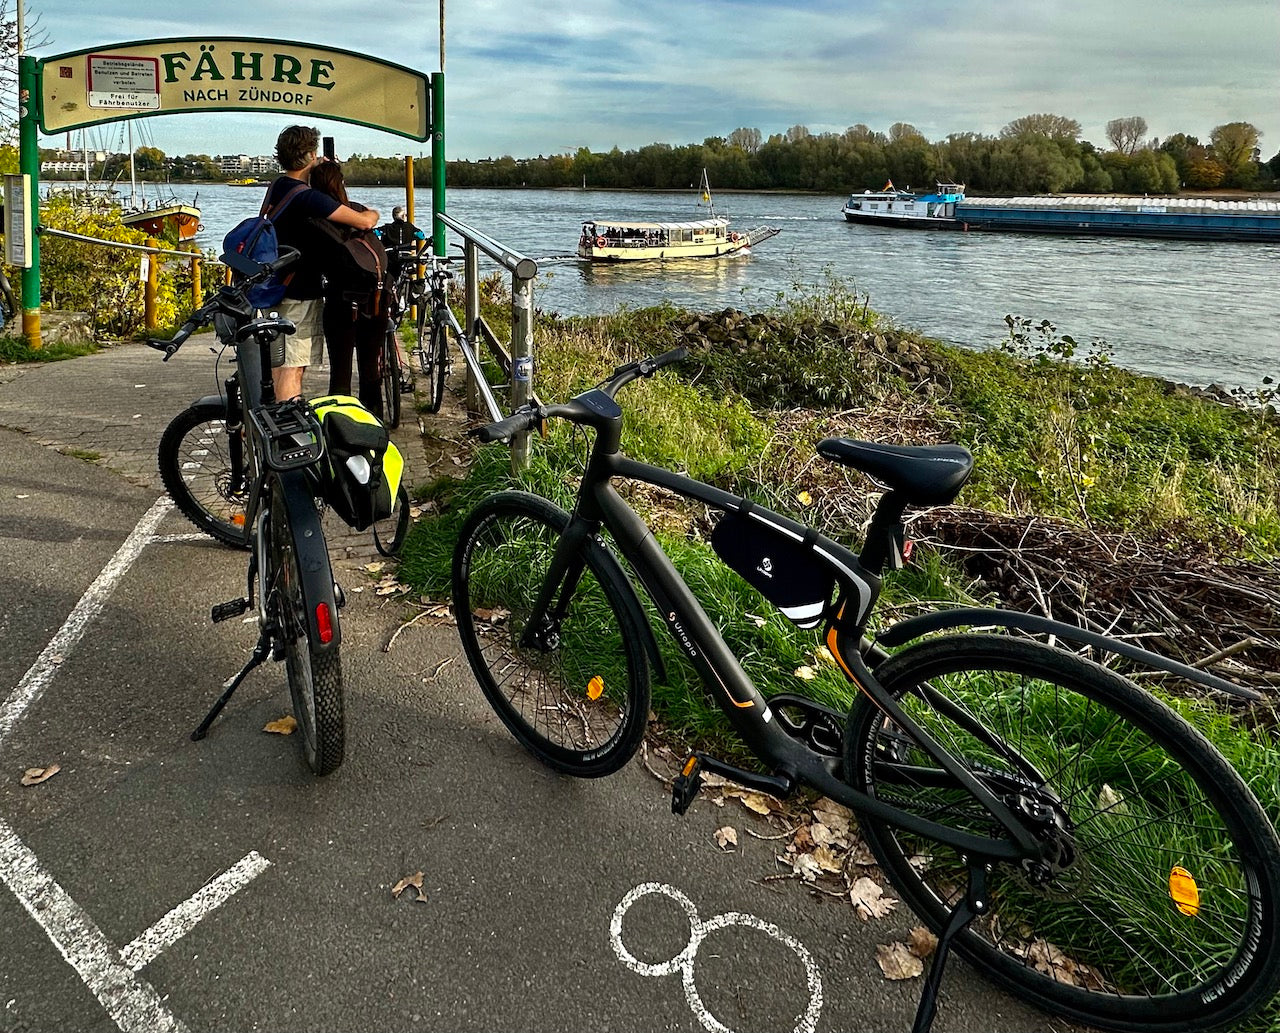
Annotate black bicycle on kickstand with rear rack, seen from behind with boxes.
[150,250,345,774]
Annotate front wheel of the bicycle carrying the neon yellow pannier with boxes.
[156,402,250,549]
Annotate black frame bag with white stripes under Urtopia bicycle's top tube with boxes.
[712,503,836,627]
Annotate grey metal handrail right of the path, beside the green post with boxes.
[436,212,538,472]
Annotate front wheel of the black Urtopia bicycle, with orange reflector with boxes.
[453,492,649,778]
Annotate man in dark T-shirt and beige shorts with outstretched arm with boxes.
[265,125,378,402]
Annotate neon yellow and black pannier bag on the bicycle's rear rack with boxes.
[311,394,404,531]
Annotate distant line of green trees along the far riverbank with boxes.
[424,114,1280,195]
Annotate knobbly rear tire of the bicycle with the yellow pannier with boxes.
[266,480,346,776]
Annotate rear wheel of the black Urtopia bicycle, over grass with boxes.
[845,635,1280,1033]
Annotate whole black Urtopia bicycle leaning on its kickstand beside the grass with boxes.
[453,349,1280,1033]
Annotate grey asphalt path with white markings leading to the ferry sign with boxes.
[0,347,1070,1033]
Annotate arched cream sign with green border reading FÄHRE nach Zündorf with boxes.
[38,36,430,140]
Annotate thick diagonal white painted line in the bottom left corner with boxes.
[0,818,187,1033]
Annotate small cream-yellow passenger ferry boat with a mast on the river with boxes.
[577,169,782,262]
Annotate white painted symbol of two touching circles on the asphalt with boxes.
[609,882,822,1033]
